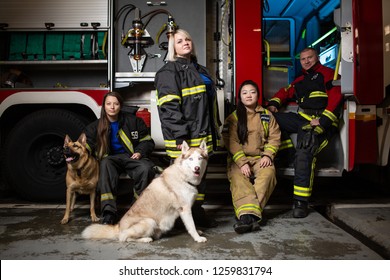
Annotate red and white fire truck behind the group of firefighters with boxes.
[0,0,390,201]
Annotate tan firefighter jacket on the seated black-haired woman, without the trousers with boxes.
[222,106,281,168]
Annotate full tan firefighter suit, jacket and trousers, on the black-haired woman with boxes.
[223,106,280,219]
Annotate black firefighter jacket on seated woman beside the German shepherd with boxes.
[85,111,154,158]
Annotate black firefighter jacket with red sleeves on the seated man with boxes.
[268,62,342,132]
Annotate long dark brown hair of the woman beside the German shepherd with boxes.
[96,91,123,160]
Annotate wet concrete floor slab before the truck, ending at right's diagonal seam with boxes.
[0,203,383,260]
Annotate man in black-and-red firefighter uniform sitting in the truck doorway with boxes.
[268,48,342,218]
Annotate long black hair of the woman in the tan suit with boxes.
[237,80,259,144]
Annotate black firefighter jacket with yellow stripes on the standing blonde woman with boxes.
[155,58,221,158]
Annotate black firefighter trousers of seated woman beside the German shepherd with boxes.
[97,153,155,213]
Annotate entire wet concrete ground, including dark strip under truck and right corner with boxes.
[0,177,390,260]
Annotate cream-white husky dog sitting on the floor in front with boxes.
[82,141,208,242]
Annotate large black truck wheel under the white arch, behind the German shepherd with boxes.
[2,109,85,201]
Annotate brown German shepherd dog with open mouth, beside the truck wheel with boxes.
[61,133,99,224]
